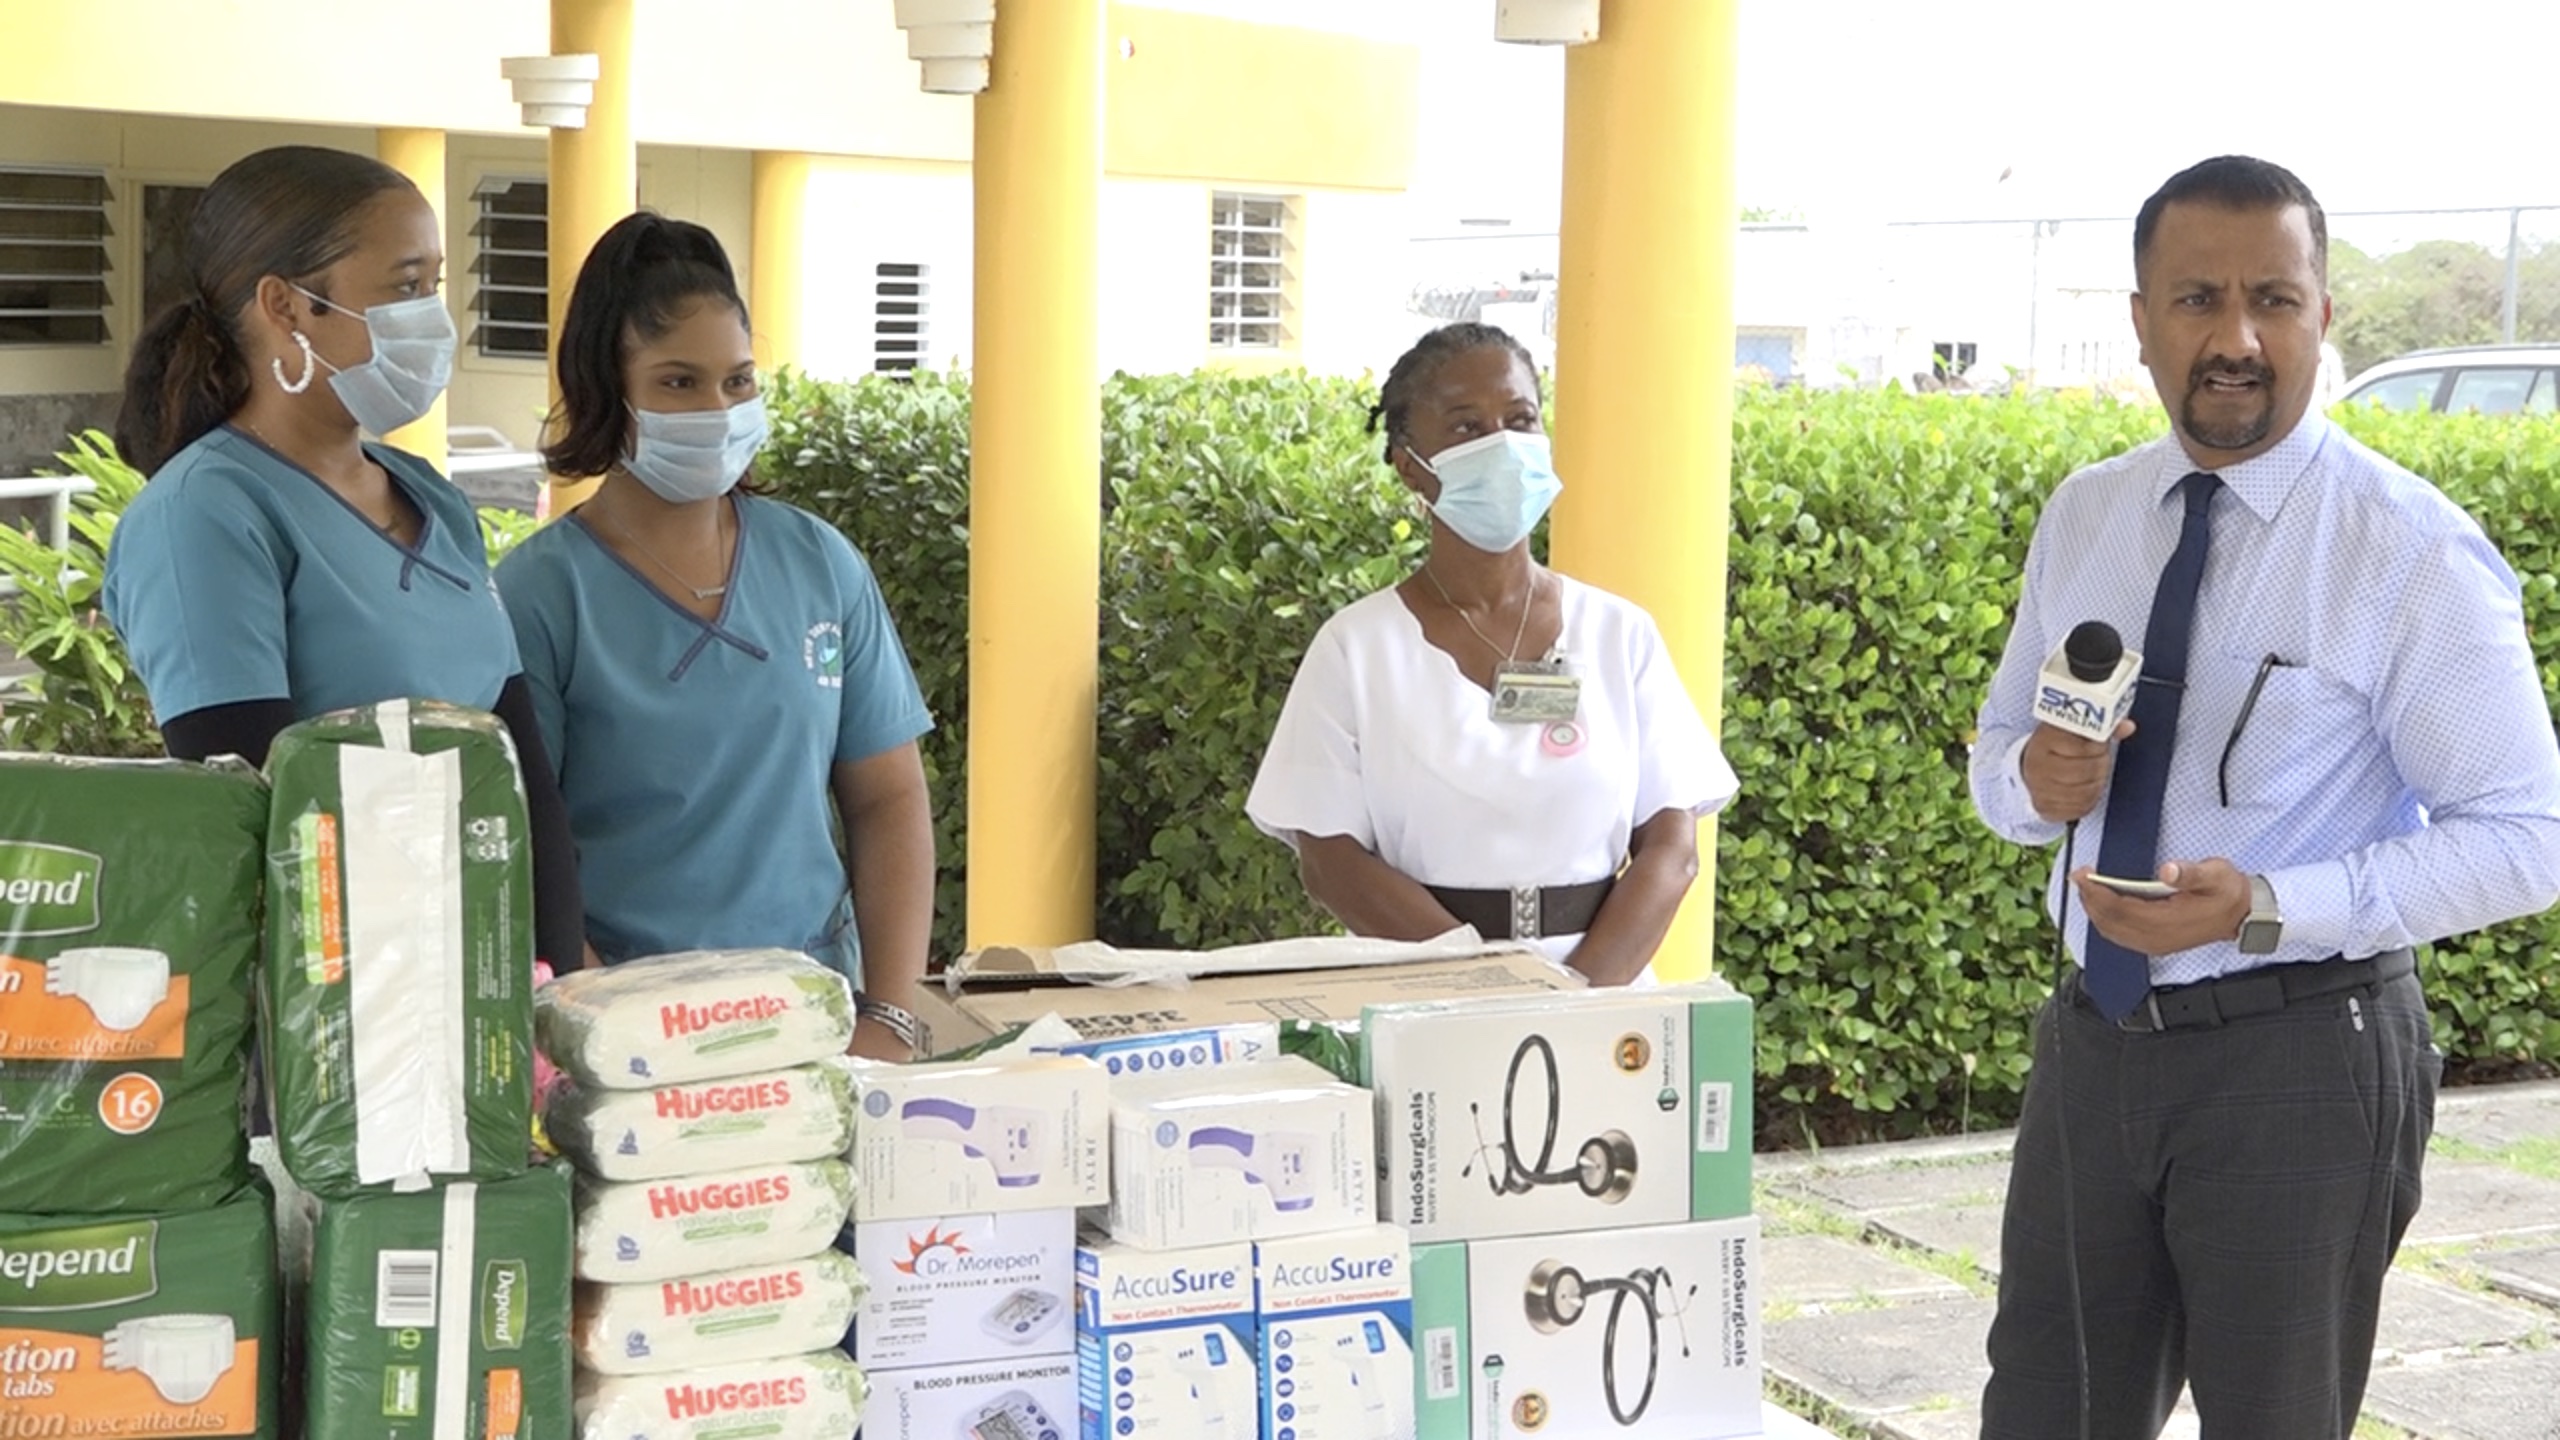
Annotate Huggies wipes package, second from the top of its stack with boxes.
[543,1056,852,1181]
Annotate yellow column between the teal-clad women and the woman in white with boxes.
[968,0,1103,945]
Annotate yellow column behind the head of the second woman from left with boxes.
[550,0,640,515]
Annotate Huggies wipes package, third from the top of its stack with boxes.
[579,1161,852,1284]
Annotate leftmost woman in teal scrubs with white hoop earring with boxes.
[102,146,584,966]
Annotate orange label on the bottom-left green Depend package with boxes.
[0,1314,259,1437]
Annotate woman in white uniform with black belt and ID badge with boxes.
[1247,325,1736,984]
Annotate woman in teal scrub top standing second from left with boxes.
[499,213,934,1058]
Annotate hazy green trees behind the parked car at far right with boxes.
[2330,241,2560,377]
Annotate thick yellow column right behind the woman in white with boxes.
[1554,0,1751,979]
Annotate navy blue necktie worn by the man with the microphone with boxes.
[2081,471,2222,1020]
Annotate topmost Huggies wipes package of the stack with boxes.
[535,951,852,1089]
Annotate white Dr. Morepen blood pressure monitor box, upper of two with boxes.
[845,1209,1075,1371]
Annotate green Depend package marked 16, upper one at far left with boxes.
[0,756,266,1215]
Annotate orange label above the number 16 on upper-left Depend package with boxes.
[0,951,187,1060]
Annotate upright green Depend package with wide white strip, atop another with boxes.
[261,700,532,1197]
